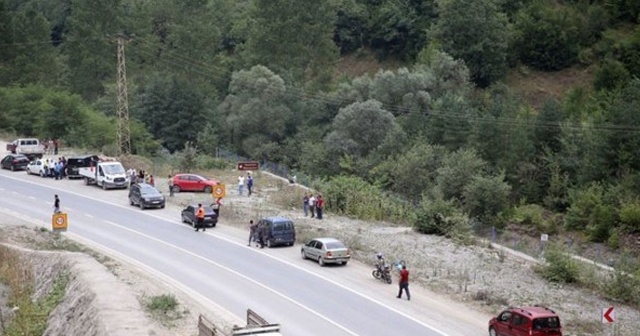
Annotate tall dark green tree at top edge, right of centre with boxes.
[430,0,511,87]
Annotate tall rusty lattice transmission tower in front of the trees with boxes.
[116,35,131,155]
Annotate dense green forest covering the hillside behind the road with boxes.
[0,0,640,258]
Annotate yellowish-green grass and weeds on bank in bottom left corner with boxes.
[0,246,69,336]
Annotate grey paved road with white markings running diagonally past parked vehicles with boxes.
[0,171,485,336]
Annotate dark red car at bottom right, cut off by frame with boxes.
[489,306,562,336]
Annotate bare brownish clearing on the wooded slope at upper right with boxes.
[505,66,596,107]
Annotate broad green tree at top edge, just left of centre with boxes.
[241,0,338,88]
